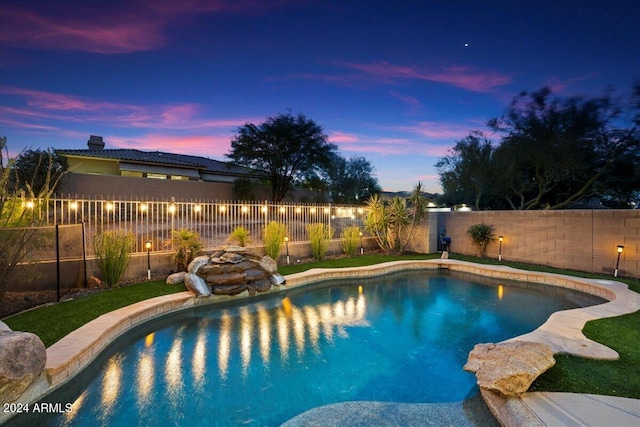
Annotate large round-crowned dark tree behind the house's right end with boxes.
[227,114,337,201]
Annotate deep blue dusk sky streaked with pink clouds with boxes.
[0,0,640,192]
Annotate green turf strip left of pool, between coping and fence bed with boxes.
[3,280,186,347]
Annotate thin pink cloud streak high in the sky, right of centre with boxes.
[336,61,511,92]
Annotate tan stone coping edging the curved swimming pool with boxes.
[0,259,640,423]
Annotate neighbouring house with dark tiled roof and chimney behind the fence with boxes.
[56,135,269,200]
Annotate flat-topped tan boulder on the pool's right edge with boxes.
[464,341,556,396]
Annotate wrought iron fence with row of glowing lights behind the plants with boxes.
[23,196,365,255]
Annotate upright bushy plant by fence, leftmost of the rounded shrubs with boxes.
[93,230,134,287]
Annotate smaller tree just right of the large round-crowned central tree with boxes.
[326,156,382,204]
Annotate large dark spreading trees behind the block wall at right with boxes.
[436,83,640,209]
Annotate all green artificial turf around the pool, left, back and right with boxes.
[4,254,640,399]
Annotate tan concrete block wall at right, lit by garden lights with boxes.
[430,209,640,277]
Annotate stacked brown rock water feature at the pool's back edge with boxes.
[167,246,285,297]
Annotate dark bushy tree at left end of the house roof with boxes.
[14,149,69,198]
